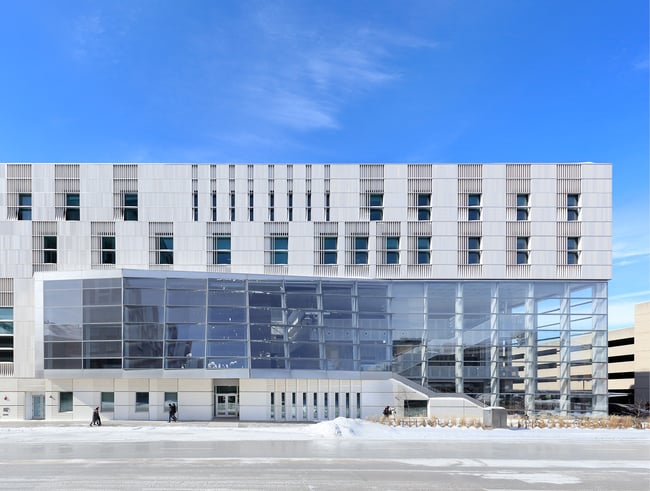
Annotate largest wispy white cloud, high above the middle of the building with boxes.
[239,4,435,130]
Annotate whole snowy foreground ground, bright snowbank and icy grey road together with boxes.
[0,418,650,491]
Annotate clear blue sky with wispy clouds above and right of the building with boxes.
[0,0,650,327]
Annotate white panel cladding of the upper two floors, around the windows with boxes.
[0,163,612,280]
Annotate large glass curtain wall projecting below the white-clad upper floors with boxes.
[43,274,607,413]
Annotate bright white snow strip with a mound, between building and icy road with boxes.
[0,418,650,444]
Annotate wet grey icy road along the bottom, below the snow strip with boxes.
[0,440,650,491]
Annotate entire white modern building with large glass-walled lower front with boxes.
[0,163,612,420]
